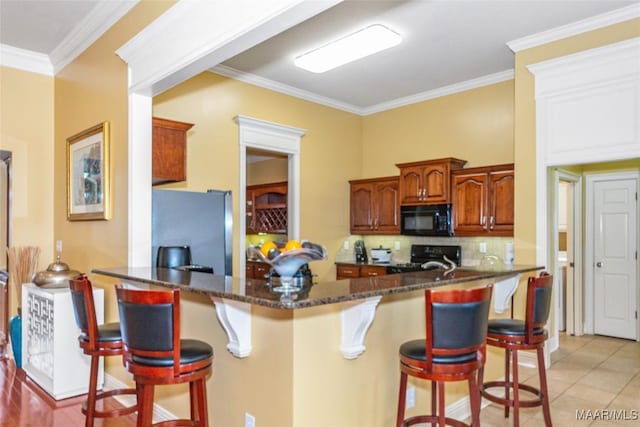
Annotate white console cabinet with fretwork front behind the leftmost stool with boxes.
[22,283,104,400]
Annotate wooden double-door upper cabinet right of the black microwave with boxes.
[451,164,514,236]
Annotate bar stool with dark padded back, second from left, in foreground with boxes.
[116,285,213,427]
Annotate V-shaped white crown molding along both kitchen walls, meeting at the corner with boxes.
[209,65,514,116]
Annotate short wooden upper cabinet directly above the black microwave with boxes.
[396,157,467,205]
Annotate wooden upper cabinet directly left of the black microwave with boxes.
[349,176,400,234]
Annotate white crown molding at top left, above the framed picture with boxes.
[49,0,139,74]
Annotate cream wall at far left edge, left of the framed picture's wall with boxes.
[0,67,54,315]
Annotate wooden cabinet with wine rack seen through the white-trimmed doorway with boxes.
[246,182,288,234]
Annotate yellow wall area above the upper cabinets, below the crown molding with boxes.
[361,80,514,178]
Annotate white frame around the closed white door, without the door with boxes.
[584,171,640,341]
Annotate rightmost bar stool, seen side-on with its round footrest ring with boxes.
[478,272,553,427]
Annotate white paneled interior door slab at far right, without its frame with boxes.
[593,179,638,339]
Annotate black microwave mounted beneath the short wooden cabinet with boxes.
[400,203,453,236]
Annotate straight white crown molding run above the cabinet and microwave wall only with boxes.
[361,69,515,116]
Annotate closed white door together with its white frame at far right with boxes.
[585,172,640,341]
